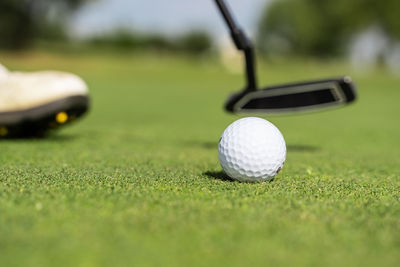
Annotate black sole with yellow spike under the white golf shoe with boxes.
[0,96,90,138]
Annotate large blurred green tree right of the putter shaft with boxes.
[258,0,400,56]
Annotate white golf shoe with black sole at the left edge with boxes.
[0,64,89,138]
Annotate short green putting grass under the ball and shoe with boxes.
[0,53,400,266]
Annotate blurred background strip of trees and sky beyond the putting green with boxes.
[0,0,400,74]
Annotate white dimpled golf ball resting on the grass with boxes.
[218,117,286,182]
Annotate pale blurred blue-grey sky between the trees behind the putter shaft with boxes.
[70,0,270,37]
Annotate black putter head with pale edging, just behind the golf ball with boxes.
[225,76,357,114]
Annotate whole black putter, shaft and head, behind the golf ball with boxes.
[215,0,357,114]
